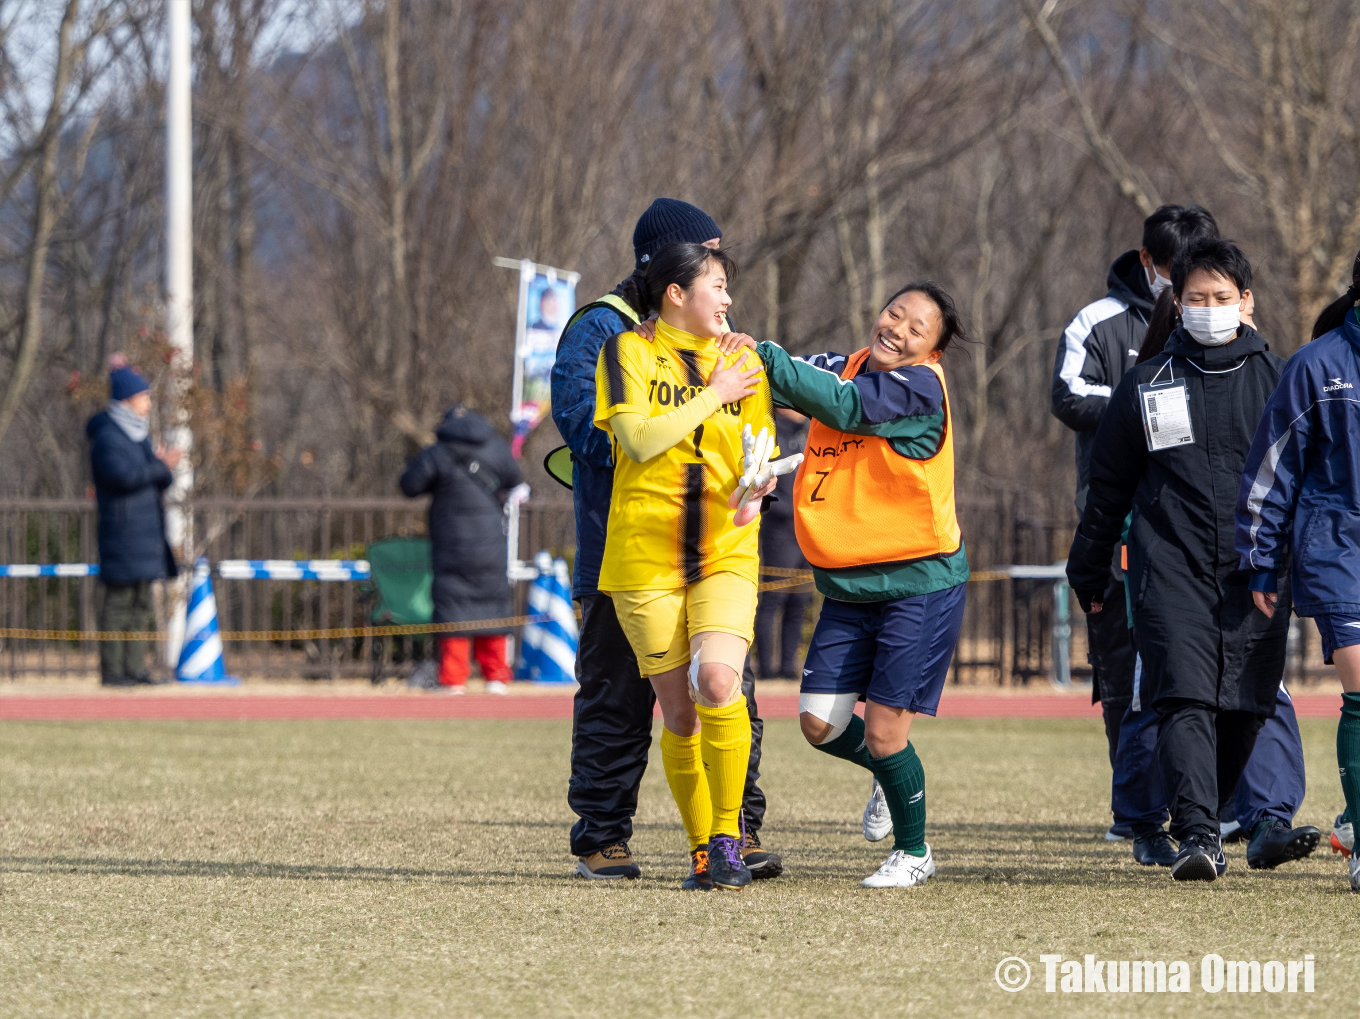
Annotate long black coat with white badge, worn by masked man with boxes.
[1068,327,1289,716]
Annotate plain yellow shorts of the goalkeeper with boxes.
[609,573,756,676]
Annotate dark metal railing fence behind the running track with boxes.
[0,495,1329,684]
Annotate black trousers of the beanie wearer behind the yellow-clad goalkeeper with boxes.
[567,595,766,856]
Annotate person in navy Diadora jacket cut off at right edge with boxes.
[1236,254,1360,891]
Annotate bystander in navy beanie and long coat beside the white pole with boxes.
[86,367,181,686]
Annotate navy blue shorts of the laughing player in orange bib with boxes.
[802,584,968,714]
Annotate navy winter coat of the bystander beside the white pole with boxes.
[86,411,178,586]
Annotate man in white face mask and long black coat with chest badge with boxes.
[1068,239,1321,880]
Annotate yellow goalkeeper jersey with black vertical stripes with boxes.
[594,321,778,592]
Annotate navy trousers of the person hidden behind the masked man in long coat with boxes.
[1110,687,1307,834]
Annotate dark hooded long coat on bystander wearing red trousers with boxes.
[401,407,524,623]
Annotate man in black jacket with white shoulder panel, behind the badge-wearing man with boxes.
[1053,205,1219,861]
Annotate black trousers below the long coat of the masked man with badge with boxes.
[1157,701,1265,841]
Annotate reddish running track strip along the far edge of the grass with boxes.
[0,691,1341,721]
